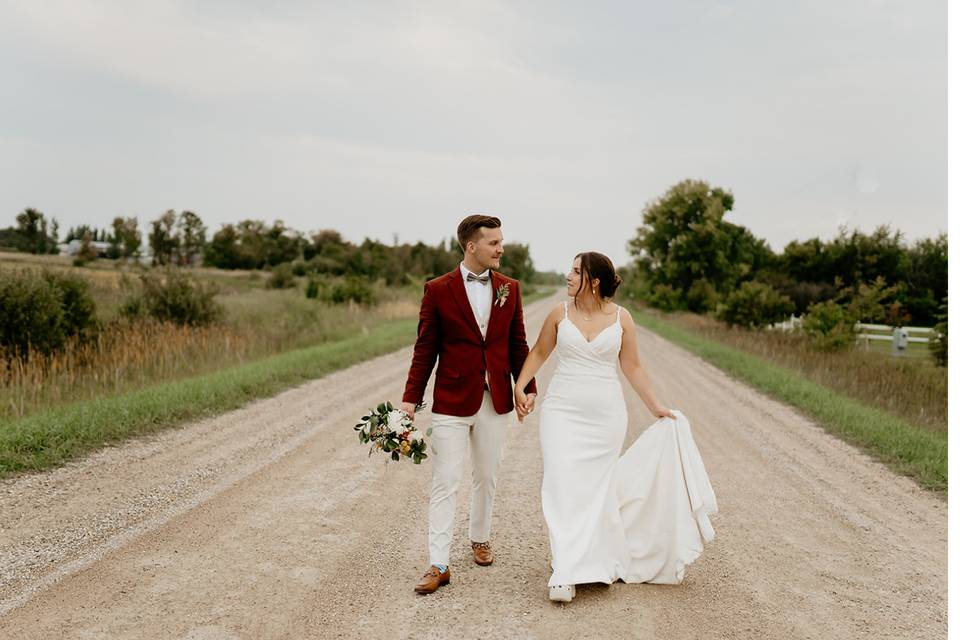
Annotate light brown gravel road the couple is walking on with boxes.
[0,297,947,640]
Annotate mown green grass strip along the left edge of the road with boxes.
[0,318,417,477]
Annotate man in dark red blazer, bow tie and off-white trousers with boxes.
[401,215,537,593]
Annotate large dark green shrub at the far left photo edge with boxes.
[0,269,96,357]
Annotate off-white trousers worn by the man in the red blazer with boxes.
[428,391,510,564]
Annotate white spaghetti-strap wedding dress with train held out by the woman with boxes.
[540,303,717,587]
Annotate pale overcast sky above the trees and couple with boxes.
[0,0,947,271]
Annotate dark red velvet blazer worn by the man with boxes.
[403,266,537,416]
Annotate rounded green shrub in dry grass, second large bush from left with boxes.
[120,269,223,326]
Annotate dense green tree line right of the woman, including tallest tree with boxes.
[628,180,947,359]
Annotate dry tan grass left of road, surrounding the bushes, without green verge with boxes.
[0,253,419,419]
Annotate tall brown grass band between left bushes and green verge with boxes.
[0,291,419,419]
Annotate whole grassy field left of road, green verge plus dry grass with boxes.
[0,253,552,475]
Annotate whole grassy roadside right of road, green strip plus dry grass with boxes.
[634,306,947,496]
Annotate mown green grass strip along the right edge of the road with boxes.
[633,310,947,493]
